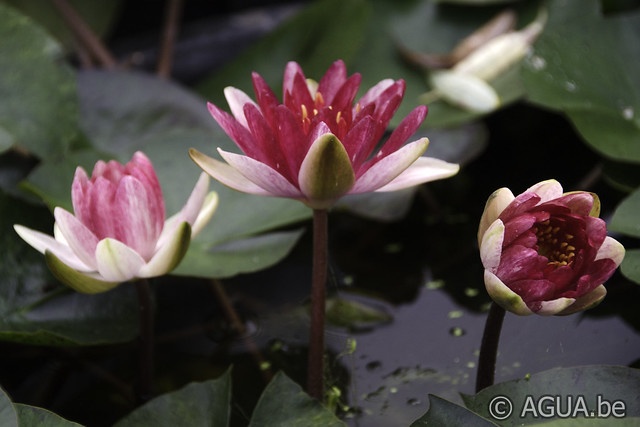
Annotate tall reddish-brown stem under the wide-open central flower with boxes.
[307,209,328,400]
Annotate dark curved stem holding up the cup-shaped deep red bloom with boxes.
[476,302,505,393]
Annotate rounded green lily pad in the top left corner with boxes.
[0,4,78,158]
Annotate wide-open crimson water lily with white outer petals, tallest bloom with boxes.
[190,61,458,209]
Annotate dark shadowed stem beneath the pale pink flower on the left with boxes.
[136,279,154,402]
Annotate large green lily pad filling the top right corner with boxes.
[523,0,640,162]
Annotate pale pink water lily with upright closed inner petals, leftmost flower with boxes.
[14,152,218,293]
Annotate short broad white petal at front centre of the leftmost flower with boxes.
[96,238,145,282]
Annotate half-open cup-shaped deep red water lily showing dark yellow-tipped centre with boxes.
[478,180,625,315]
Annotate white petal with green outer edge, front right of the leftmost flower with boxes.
[137,222,191,278]
